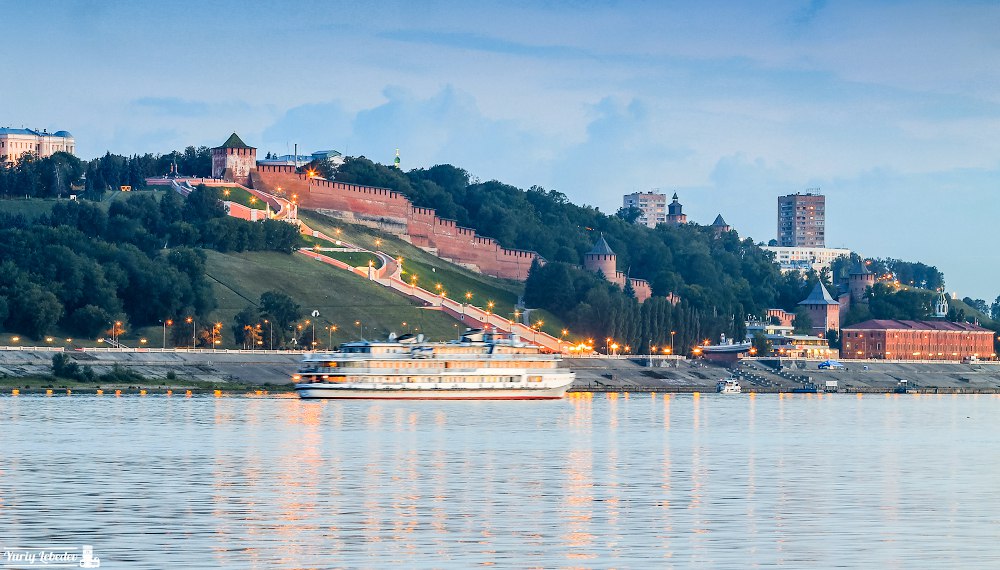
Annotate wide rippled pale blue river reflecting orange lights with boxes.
[0,394,1000,569]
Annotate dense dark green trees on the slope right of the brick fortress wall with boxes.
[336,157,819,346]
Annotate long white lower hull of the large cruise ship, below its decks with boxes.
[295,381,572,400]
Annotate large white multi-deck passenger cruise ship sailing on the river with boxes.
[294,330,575,400]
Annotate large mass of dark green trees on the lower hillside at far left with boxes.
[0,186,300,339]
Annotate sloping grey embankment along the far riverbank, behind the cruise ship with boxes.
[0,348,1000,393]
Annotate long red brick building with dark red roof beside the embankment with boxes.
[840,320,996,360]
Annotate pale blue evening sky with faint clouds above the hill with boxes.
[7,0,1000,302]
